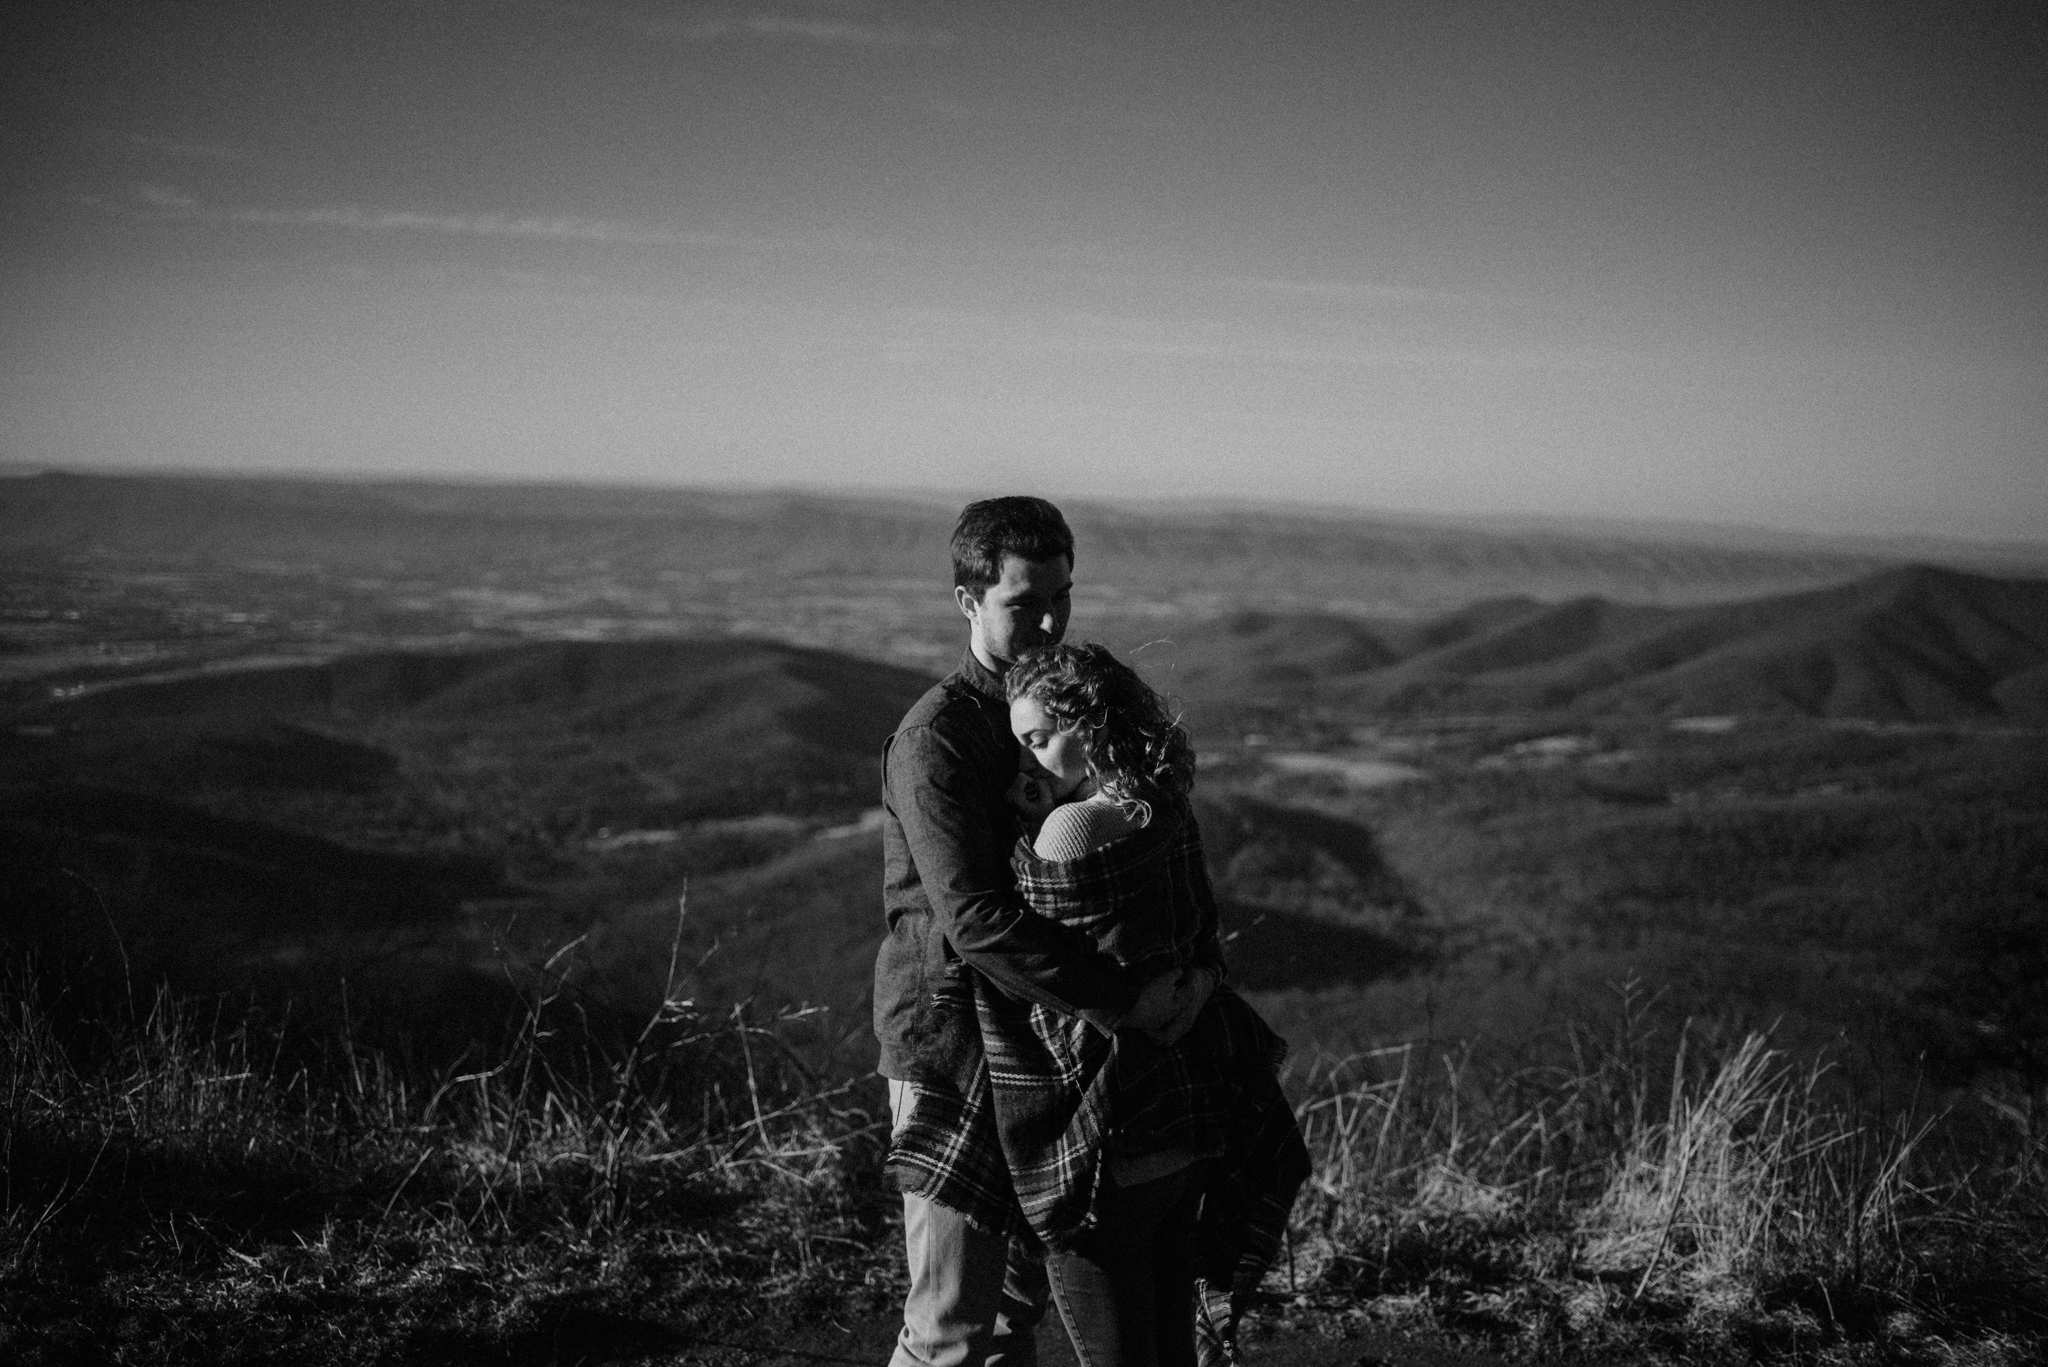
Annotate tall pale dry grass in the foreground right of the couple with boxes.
[1292,987,2048,1363]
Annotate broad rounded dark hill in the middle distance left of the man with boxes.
[6,639,930,828]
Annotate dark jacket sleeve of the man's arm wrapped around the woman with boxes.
[883,726,1137,1031]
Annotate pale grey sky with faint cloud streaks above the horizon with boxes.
[0,0,2048,541]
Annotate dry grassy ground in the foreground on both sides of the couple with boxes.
[0,950,2048,1365]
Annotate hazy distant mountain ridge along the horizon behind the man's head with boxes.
[12,471,2048,615]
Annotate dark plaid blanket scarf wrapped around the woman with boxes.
[891,805,1309,1291]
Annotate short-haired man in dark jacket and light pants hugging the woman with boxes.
[874,498,1212,1367]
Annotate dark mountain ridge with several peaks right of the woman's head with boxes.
[1153,566,2048,726]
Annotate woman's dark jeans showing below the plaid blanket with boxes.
[1047,1164,1206,1367]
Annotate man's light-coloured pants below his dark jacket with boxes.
[889,1078,1049,1367]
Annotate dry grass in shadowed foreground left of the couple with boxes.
[0,926,899,1363]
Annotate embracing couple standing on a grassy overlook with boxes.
[874,498,1307,1367]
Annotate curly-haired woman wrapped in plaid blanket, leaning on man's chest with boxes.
[977,646,1309,1367]
